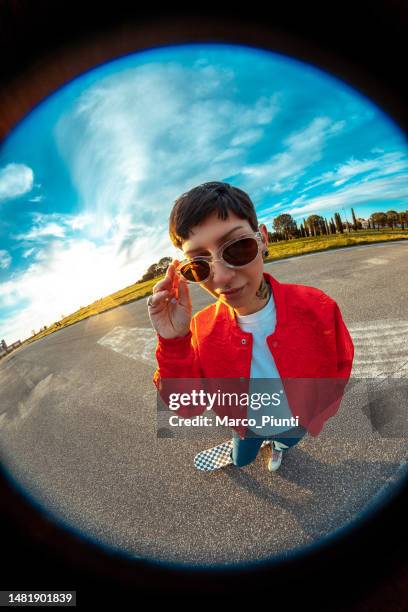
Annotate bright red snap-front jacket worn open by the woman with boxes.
[153,271,354,438]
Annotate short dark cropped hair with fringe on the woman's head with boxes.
[169,181,258,248]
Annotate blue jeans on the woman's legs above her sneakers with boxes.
[231,426,307,467]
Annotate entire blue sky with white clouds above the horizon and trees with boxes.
[0,44,408,343]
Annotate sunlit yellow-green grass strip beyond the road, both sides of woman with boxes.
[11,229,408,346]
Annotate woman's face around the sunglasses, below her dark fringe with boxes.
[182,211,269,315]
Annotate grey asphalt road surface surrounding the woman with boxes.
[0,242,408,565]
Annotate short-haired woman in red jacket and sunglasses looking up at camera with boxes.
[148,182,354,471]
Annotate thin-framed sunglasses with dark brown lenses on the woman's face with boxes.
[176,232,262,283]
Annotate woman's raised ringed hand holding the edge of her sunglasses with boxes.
[148,259,192,338]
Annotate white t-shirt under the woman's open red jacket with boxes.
[235,290,294,437]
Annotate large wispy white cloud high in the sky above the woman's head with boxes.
[55,60,280,239]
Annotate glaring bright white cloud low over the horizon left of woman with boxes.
[0,215,174,343]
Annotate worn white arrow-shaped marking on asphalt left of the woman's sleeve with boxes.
[97,326,157,365]
